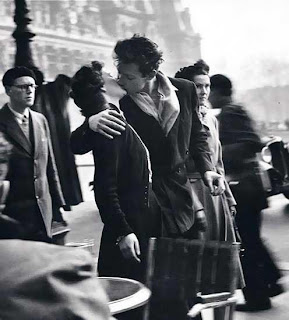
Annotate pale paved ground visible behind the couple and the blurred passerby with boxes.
[65,192,289,320]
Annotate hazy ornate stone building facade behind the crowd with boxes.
[0,0,200,84]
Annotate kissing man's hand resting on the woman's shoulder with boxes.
[88,109,125,139]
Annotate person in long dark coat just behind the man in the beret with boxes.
[32,74,83,210]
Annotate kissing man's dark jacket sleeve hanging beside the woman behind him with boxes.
[190,84,214,174]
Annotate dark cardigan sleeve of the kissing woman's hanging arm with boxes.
[93,133,133,236]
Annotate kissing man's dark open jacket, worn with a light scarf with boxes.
[120,78,214,235]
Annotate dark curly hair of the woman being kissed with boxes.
[70,61,107,117]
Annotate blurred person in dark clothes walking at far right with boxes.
[209,74,283,311]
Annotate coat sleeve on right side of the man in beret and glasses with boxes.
[43,117,65,208]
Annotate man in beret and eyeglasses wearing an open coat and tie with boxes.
[0,67,65,242]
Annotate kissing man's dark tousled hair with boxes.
[114,34,163,76]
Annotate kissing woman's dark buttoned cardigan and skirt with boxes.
[71,119,153,280]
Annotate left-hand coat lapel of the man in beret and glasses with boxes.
[0,105,32,155]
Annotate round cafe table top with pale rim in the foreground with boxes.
[98,277,151,315]
